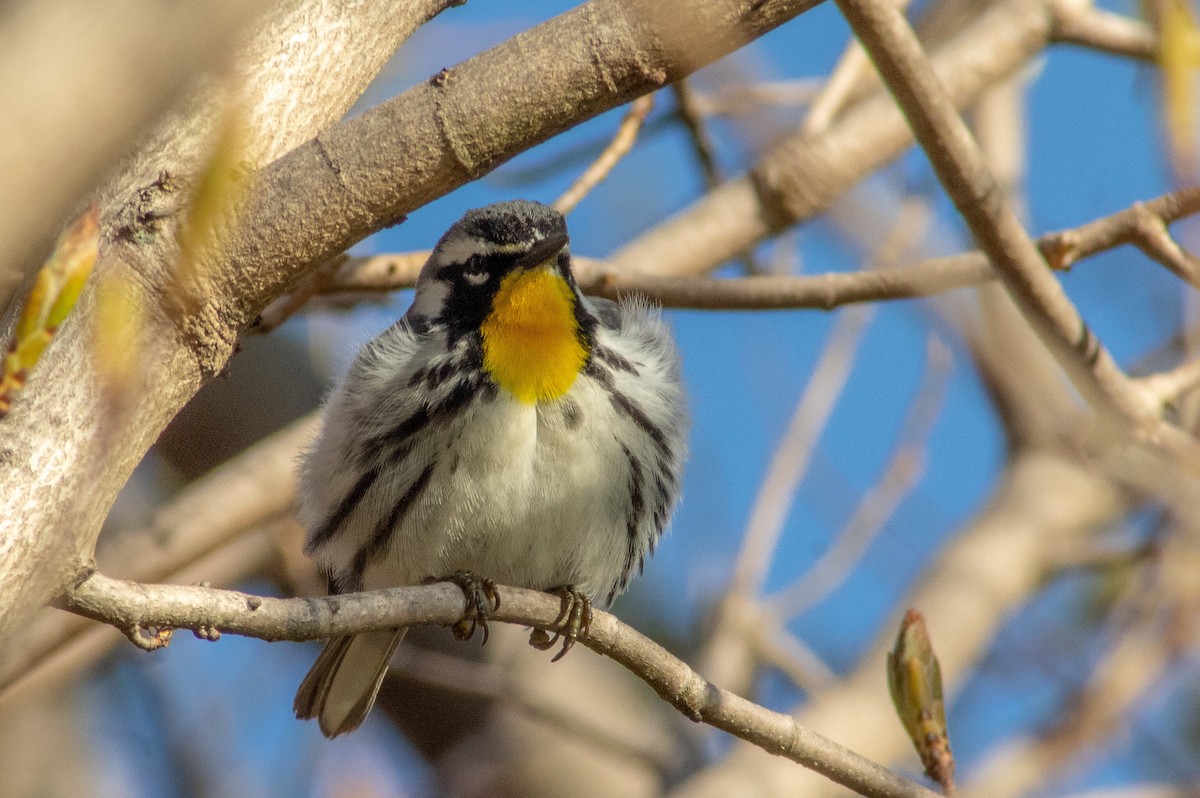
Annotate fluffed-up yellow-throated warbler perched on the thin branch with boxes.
[295,200,686,737]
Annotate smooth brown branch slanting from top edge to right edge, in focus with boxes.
[838,0,1200,458]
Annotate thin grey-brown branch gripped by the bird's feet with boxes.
[60,574,937,798]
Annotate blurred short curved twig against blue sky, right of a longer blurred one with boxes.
[766,337,952,618]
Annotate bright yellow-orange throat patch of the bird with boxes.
[480,268,588,404]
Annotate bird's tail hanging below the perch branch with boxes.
[292,629,407,737]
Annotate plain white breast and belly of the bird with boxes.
[364,379,630,596]
